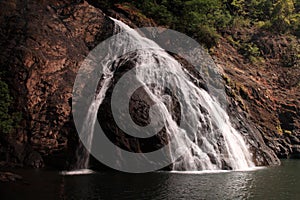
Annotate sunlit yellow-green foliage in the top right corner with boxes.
[227,0,300,37]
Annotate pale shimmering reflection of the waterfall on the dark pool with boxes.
[164,172,253,199]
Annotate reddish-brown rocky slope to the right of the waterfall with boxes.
[214,31,300,158]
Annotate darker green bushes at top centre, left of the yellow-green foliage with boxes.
[131,0,231,47]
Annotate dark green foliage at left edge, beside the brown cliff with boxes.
[0,79,21,134]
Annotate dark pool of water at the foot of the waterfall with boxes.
[0,160,300,200]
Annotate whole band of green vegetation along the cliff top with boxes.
[93,0,300,47]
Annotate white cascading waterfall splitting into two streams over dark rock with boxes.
[75,16,254,171]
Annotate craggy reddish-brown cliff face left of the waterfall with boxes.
[0,0,113,167]
